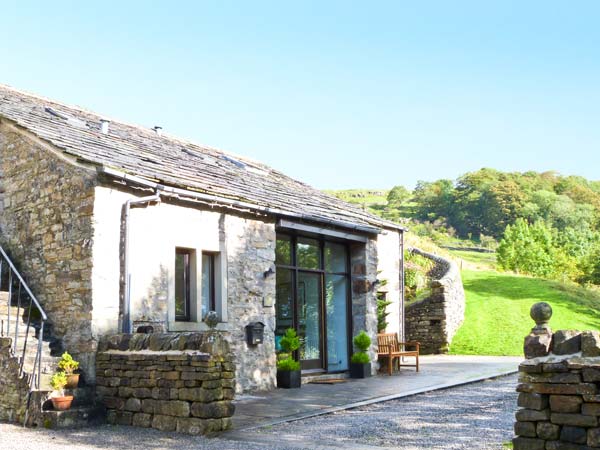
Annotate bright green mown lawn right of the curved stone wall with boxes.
[450,270,600,355]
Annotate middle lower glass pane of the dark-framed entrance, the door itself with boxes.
[297,272,323,369]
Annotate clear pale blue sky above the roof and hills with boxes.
[0,0,600,189]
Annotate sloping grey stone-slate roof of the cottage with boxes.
[0,84,402,229]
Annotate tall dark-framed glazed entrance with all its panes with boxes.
[275,234,350,372]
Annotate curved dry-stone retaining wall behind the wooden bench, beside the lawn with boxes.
[405,248,465,354]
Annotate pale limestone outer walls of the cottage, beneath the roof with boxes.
[0,121,401,392]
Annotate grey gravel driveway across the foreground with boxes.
[0,375,516,450]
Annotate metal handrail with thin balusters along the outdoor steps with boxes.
[0,246,48,391]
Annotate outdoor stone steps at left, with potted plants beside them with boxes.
[0,291,105,428]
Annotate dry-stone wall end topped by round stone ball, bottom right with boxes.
[513,304,600,450]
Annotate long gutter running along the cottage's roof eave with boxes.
[98,166,405,234]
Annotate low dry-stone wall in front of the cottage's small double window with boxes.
[96,333,235,434]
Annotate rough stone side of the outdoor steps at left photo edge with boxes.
[0,337,29,422]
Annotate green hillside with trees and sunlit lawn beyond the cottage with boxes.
[331,181,600,355]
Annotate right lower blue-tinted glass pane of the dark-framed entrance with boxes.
[325,275,348,372]
